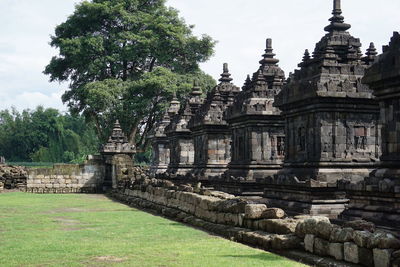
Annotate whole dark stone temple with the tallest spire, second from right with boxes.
[265,0,381,217]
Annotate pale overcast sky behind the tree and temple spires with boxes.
[0,0,400,110]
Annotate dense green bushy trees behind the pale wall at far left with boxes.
[0,107,99,162]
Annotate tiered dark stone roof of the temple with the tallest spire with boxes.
[276,0,376,106]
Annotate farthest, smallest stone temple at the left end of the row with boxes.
[149,95,180,175]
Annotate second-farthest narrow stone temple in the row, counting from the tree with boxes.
[166,82,204,178]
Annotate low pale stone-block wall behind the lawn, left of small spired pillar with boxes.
[26,156,105,193]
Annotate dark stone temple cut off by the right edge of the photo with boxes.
[339,32,400,227]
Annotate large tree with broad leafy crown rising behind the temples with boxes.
[45,0,215,151]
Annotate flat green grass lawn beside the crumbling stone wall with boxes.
[0,193,303,267]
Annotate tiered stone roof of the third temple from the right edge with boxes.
[227,39,285,119]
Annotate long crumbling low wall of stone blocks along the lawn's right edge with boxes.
[112,170,400,267]
